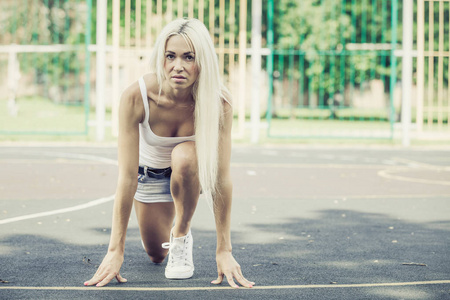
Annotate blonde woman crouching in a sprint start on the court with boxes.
[84,19,254,288]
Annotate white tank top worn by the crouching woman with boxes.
[139,77,195,169]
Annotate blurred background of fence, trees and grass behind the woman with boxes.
[0,0,450,146]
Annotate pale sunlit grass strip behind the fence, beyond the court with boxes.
[0,97,448,145]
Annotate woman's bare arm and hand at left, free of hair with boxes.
[84,83,143,286]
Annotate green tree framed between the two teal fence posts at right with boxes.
[266,0,400,105]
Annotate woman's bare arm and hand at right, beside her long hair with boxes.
[212,103,255,288]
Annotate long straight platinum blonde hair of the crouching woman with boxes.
[150,19,228,196]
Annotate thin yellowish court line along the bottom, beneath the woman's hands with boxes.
[0,280,450,292]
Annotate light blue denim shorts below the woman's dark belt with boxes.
[134,175,173,203]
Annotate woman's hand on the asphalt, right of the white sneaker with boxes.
[211,252,255,288]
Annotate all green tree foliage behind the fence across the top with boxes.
[0,0,450,104]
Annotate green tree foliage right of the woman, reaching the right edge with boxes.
[268,0,450,98]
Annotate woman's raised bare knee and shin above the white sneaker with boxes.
[170,142,200,237]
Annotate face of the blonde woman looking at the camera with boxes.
[164,35,199,89]
